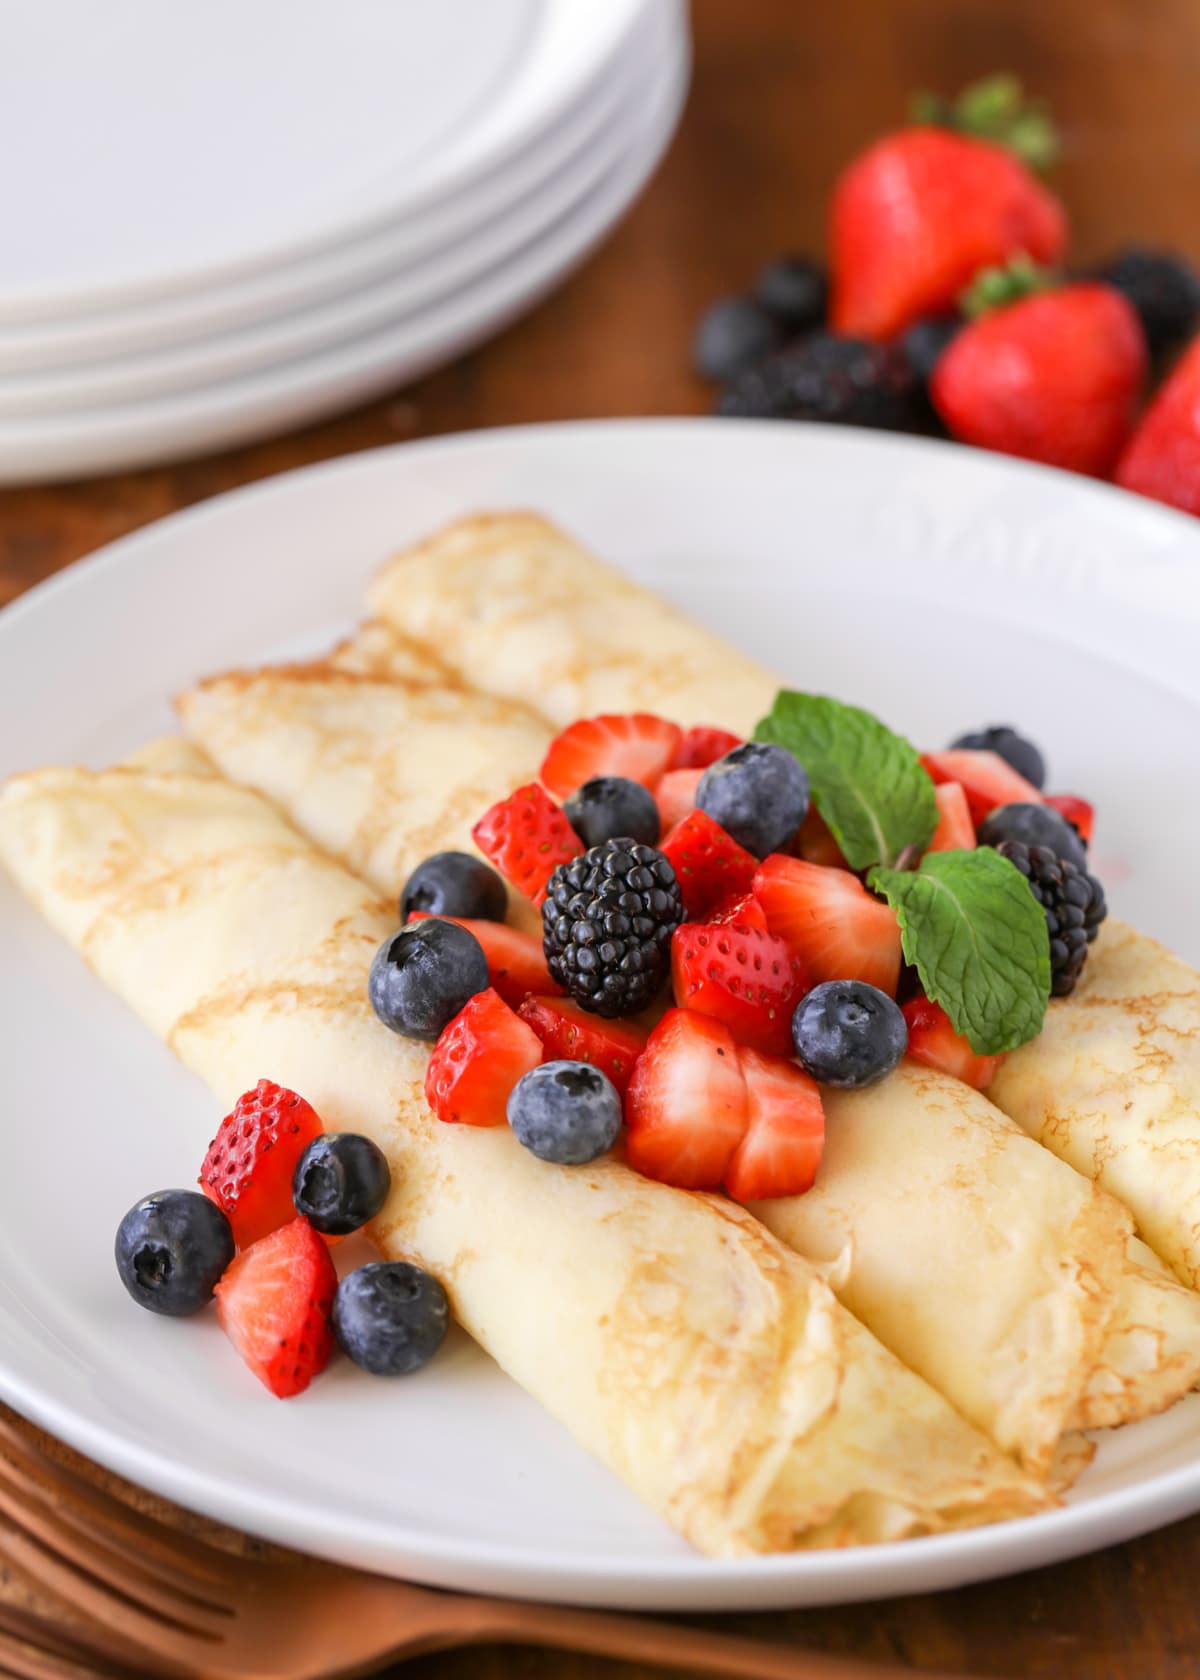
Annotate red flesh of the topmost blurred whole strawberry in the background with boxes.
[830,126,1067,339]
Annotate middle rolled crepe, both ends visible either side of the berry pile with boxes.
[180,648,1200,1473]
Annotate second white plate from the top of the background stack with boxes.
[0,0,672,375]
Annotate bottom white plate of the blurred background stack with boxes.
[0,49,687,484]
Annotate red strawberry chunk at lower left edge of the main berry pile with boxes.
[425,986,543,1126]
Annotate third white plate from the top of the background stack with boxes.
[0,10,682,423]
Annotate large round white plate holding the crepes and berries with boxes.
[0,420,1200,1609]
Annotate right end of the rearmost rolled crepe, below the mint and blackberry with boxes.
[990,919,1200,1289]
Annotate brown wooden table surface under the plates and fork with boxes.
[0,0,1200,1680]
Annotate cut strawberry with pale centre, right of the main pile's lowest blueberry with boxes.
[625,1010,746,1189]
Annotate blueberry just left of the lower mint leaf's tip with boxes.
[792,979,908,1090]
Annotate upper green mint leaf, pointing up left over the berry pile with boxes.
[755,689,938,869]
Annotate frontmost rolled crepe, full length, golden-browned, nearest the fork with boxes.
[0,749,1049,1554]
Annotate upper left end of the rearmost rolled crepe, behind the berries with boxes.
[370,514,778,734]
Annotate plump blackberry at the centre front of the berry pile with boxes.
[541,838,684,1016]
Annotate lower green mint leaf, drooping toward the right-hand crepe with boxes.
[871,847,1050,1055]
